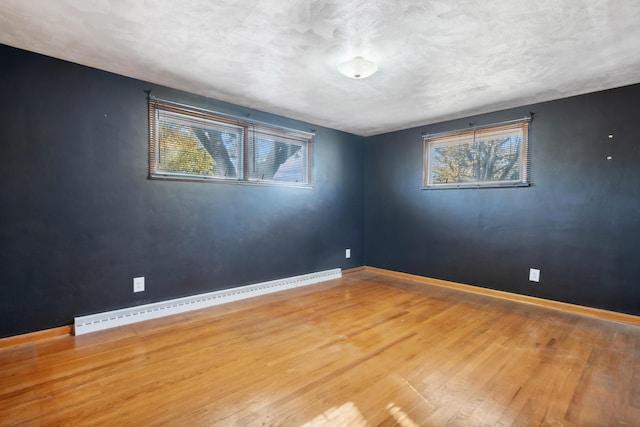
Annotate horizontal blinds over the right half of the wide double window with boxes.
[249,126,311,184]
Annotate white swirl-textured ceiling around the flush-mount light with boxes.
[0,0,640,135]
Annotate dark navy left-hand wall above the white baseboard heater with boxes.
[0,46,364,337]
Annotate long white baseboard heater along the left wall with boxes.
[74,268,342,335]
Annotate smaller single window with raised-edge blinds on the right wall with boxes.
[423,118,530,188]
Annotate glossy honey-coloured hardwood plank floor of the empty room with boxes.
[0,271,640,427]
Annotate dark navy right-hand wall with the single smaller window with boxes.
[365,85,640,315]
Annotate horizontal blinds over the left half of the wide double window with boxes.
[152,103,244,180]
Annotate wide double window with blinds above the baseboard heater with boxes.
[149,99,313,186]
